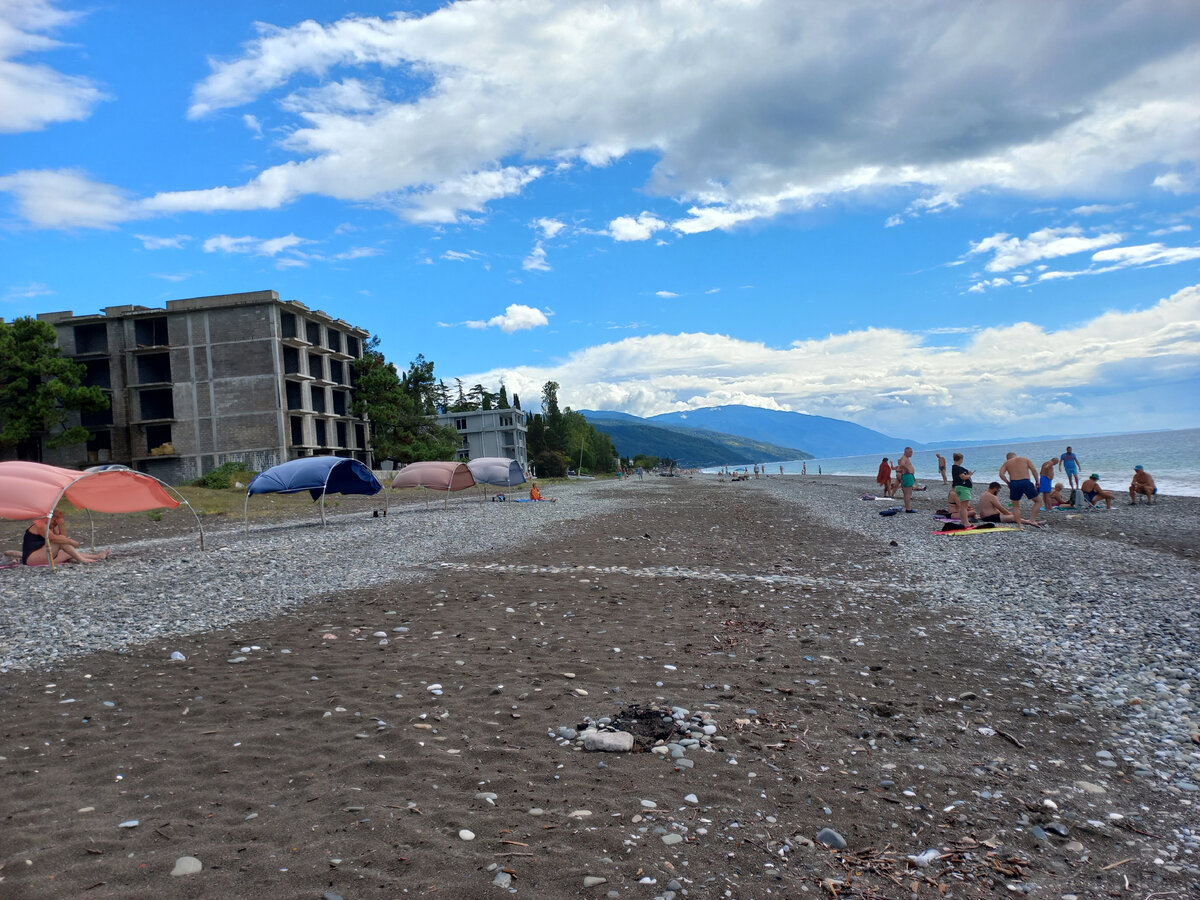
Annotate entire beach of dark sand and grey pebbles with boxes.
[0,476,1200,900]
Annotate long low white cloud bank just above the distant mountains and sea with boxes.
[453,284,1200,433]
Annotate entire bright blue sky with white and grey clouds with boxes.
[0,0,1200,440]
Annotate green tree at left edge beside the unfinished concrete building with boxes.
[0,317,108,458]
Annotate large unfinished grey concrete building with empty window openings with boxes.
[38,290,372,481]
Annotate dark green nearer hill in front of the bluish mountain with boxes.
[576,409,811,468]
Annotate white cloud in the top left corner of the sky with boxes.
[0,0,108,134]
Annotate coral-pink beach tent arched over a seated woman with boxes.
[0,461,204,569]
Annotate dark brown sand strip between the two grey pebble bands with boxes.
[0,480,1196,900]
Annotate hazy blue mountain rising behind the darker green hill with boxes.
[646,406,923,458]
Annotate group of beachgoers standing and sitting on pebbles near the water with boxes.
[931,446,1158,528]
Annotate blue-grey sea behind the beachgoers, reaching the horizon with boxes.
[704,428,1200,497]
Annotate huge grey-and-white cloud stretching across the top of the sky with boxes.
[9,0,1200,232]
